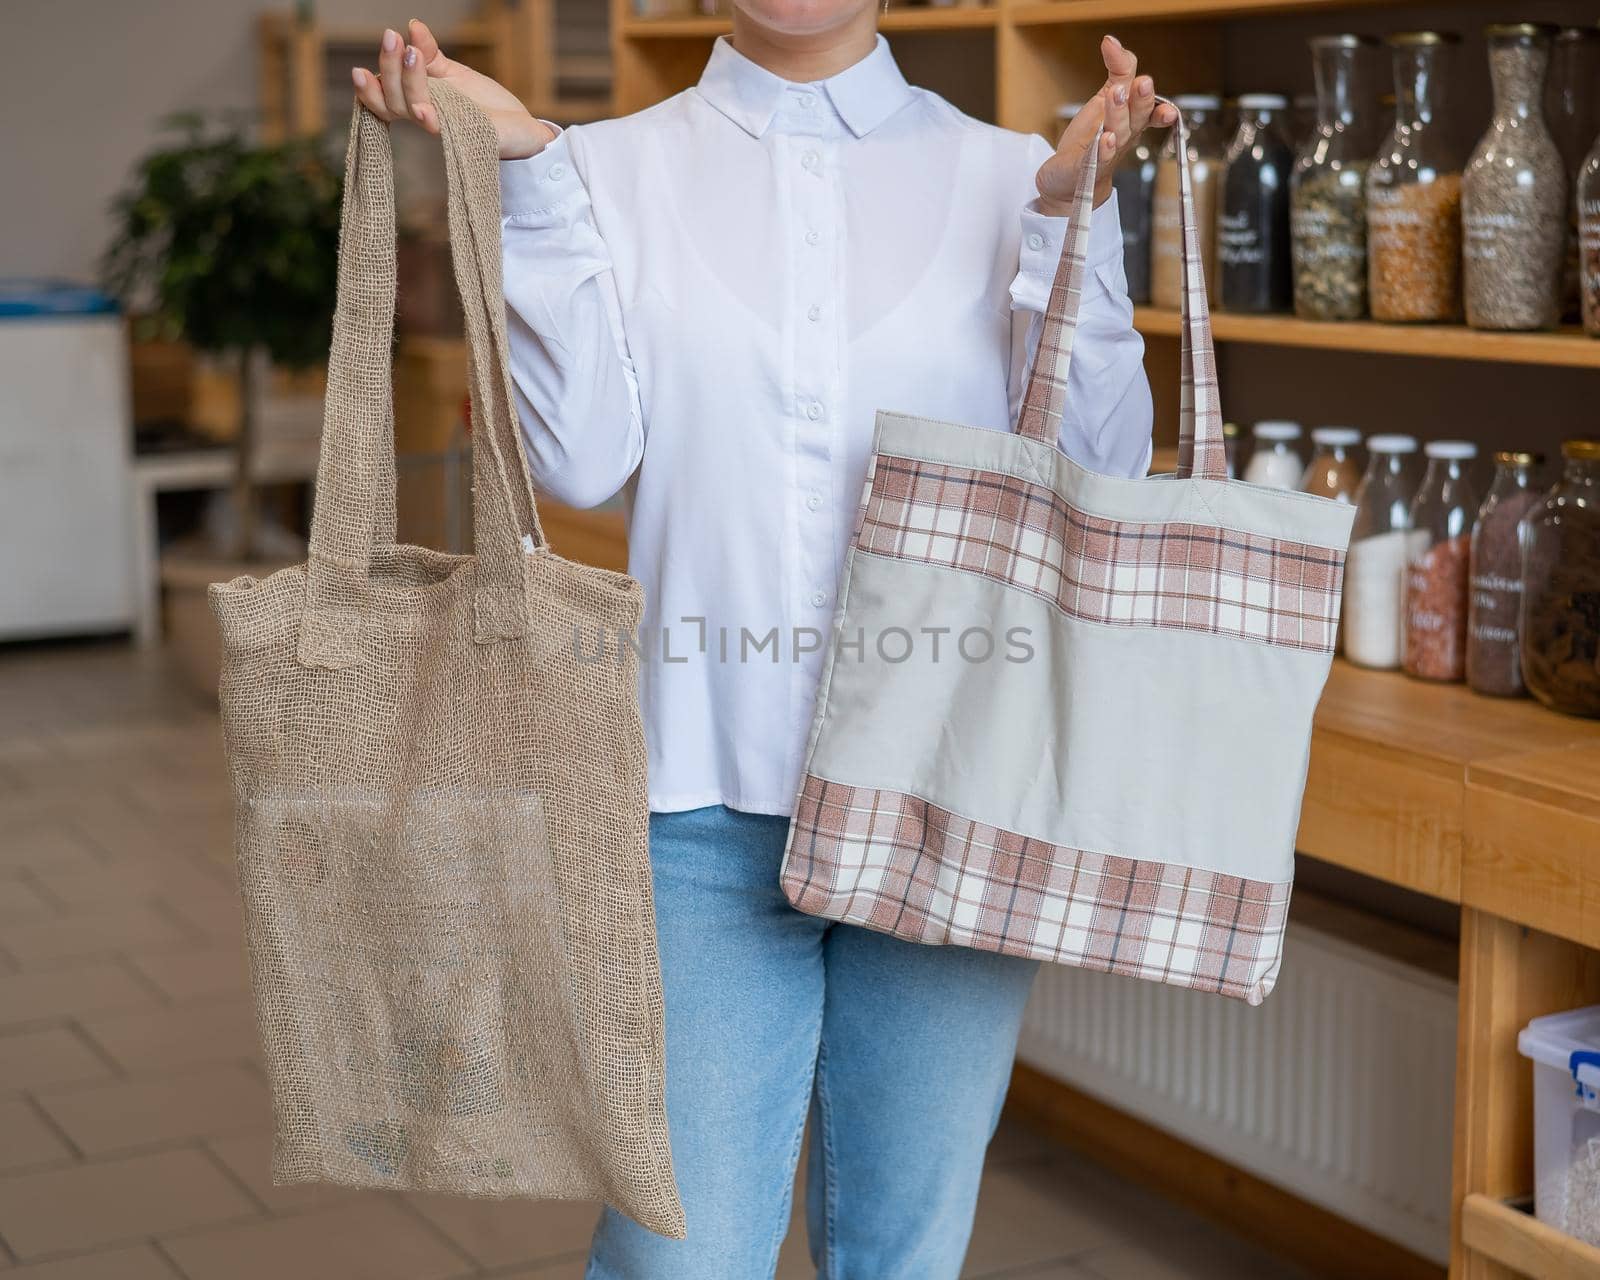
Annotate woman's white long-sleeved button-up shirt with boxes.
[501,35,1150,814]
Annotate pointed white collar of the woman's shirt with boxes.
[698,32,912,138]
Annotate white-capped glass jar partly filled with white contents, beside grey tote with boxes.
[1341,435,1416,670]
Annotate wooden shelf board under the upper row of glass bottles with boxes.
[1133,307,1600,370]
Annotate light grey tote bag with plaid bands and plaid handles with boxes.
[782,104,1352,1003]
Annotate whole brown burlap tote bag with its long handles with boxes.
[211,86,683,1237]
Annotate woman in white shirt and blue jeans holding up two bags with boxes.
[354,10,1173,1280]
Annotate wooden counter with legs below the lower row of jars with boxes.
[1299,661,1600,1280]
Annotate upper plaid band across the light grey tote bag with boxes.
[856,454,1344,653]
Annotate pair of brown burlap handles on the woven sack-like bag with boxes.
[299,85,544,669]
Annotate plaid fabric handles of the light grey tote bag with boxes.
[1016,98,1227,480]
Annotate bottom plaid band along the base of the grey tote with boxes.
[782,774,1290,1005]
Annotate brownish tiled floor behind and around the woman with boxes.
[0,645,1298,1280]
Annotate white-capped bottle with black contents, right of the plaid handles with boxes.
[1216,93,1294,314]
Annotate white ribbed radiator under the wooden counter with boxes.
[1019,922,1456,1262]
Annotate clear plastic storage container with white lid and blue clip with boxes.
[1517,1005,1600,1245]
